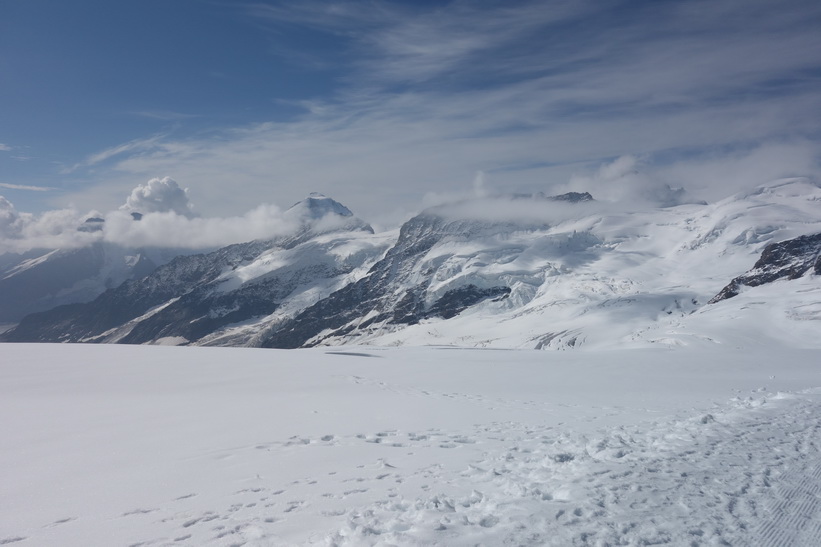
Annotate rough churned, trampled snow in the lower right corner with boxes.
[322,390,821,547]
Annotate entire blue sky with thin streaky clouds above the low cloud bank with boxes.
[0,0,821,248]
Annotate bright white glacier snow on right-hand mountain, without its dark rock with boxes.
[332,179,821,349]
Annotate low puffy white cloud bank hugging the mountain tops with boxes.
[0,150,812,254]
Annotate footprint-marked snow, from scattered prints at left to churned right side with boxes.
[9,388,821,547]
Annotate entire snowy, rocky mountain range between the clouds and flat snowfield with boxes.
[2,182,821,349]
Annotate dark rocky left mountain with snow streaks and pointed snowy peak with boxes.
[4,195,392,345]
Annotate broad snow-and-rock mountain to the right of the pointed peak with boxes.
[264,179,821,348]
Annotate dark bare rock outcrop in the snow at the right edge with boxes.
[709,233,821,304]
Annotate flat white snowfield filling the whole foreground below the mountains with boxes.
[0,345,821,547]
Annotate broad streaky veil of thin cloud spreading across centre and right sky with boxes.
[56,0,821,223]
